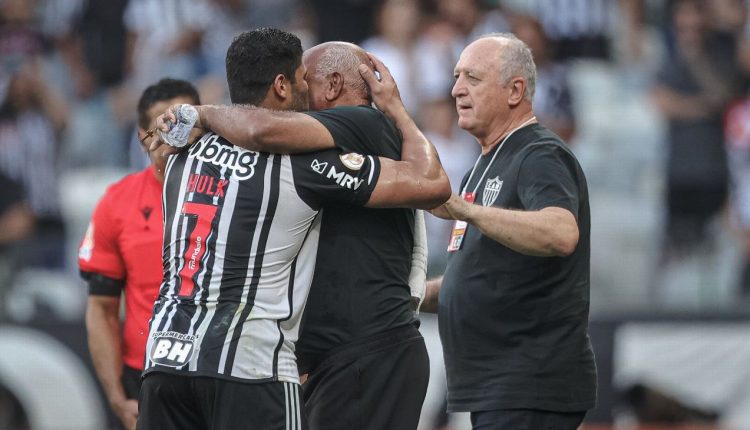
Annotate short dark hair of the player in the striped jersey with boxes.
[227,28,302,105]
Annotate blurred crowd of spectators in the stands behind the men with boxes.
[0,0,750,315]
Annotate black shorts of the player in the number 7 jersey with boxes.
[137,372,306,430]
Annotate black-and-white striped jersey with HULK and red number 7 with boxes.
[145,133,380,383]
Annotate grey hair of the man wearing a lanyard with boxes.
[480,33,536,102]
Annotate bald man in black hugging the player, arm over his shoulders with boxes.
[155,42,434,430]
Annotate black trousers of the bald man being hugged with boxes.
[302,325,430,430]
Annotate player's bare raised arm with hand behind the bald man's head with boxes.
[359,54,451,209]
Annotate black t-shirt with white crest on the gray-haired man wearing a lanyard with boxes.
[438,124,596,412]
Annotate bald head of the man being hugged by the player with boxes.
[303,42,371,110]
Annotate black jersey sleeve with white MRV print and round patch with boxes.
[291,149,380,209]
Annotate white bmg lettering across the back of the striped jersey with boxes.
[190,133,258,181]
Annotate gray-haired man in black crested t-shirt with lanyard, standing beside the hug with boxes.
[425,34,596,430]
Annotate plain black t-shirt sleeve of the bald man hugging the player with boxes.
[307,106,401,160]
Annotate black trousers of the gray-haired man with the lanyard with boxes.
[471,409,586,430]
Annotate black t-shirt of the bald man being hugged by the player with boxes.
[297,106,414,373]
